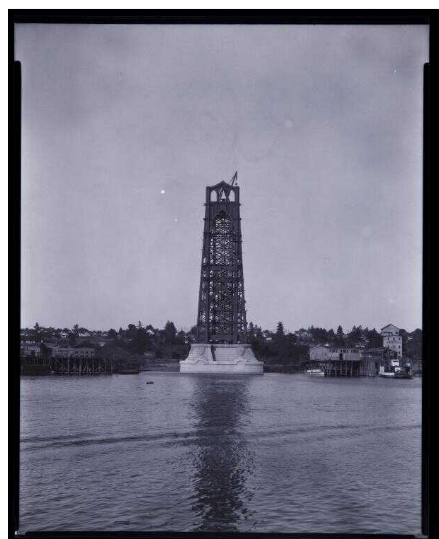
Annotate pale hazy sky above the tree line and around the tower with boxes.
[15,24,428,331]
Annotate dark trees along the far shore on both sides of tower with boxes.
[25,320,422,365]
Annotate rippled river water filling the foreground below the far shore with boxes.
[20,372,421,533]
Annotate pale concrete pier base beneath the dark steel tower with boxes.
[180,343,264,374]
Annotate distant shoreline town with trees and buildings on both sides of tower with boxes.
[20,321,422,372]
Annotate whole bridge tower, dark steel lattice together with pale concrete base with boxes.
[180,172,264,374]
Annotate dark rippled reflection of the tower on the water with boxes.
[192,375,254,531]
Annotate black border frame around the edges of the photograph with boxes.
[6,8,437,539]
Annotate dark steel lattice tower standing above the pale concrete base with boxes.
[197,173,247,344]
